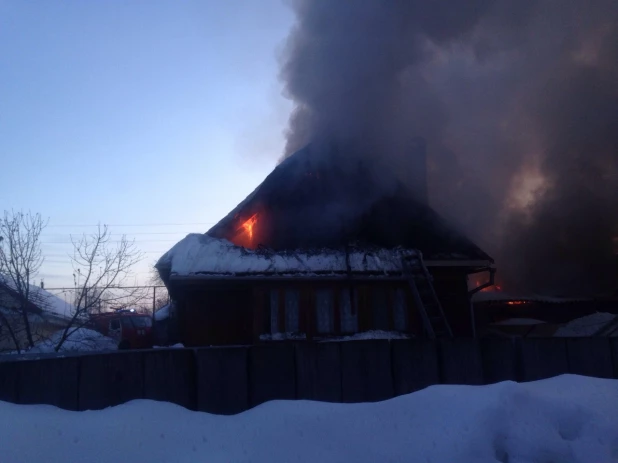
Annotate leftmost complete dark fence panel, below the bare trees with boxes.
[18,357,79,410]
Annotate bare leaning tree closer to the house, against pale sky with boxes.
[55,225,144,351]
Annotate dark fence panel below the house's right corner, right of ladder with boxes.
[438,338,484,385]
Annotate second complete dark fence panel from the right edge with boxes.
[521,338,569,381]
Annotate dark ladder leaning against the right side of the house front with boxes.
[401,251,453,339]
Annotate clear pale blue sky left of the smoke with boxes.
[0,0,293,287]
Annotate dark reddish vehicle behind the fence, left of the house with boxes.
[91,309,153,349]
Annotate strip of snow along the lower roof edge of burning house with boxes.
[157,234,416,276]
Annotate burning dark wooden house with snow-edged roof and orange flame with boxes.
[157,140,493,346]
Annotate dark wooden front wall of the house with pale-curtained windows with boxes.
[175,269,472,346]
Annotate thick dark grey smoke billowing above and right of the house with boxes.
[281,0,618,294]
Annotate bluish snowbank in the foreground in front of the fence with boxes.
[0,376,618,463]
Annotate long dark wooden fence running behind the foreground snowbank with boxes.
[0,338,618,414]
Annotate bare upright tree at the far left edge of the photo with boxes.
[0,211,47,351]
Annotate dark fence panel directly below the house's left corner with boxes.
[144,349,197,410]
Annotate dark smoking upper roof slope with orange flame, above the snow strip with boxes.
[207,145,493,262]
